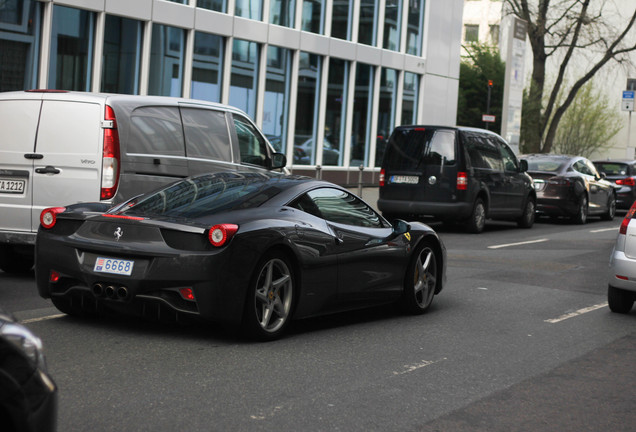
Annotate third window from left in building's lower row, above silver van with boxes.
[101,15,143,94]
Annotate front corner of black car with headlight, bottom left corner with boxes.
[0,308,57,432]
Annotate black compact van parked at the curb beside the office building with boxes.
[378,126,536,233]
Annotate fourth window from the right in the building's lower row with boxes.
[322,57,350,165]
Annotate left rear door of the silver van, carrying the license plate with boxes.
[0,98,42,238]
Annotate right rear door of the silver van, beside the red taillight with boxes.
[30,100,104,231]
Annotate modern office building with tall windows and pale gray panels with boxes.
[0,0,463,184]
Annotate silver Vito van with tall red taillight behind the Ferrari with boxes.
[0,90,286,273]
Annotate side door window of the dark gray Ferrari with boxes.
[307,188,383,228]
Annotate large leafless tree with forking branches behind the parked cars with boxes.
[505,0,636,153]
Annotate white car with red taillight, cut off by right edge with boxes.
[607,201,636,313]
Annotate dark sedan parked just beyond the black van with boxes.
[521,154,616,224]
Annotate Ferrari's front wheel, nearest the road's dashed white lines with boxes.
[402,241,439,315]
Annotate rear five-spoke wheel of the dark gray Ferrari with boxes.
[243,252,296,341]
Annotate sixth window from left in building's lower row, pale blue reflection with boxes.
[230,39,259,118]
